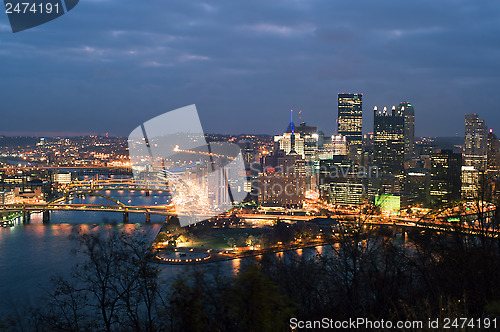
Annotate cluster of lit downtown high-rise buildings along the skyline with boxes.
[251,93,500,211]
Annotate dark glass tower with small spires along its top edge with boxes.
[373,106,405,175]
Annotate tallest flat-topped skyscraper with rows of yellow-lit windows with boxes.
[338,93,363,146]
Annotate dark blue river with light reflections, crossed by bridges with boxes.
[0,190,324,314]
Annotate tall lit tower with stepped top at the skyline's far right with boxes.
[465,114,488,171]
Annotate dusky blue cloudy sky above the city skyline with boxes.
[0,0,500,136]
